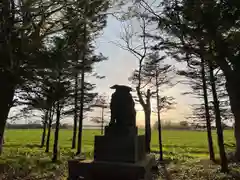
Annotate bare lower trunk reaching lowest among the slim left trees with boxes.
[52,101,61,162]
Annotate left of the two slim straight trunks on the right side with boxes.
[201,57,215,161]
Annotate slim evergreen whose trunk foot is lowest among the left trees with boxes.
[49,38,72,161]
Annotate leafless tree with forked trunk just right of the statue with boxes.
[115,14,152,152]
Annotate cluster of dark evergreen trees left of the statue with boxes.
[0,0,111,161]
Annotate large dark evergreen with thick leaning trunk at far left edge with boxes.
[0,0,69,154]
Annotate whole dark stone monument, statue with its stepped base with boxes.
[68,85,155,180]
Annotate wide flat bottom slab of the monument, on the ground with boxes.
[68,155,156,180]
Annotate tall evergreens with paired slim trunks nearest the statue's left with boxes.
[62,0,109,154]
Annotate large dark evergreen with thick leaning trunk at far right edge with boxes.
[133,0,240,167]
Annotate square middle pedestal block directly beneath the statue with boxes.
[94,135,146,163]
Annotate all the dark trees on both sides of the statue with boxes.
[0,0,240,172]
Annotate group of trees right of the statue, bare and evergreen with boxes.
[116,0,240,172]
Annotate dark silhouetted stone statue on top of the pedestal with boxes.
[109,85,136,127]
